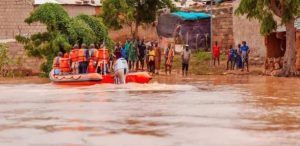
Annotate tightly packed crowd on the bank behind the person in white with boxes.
[114,38,175,74]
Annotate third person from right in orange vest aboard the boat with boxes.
[78,44,89,74]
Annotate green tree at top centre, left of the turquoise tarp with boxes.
[101,0,175,36]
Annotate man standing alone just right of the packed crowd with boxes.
[181,45,192,76]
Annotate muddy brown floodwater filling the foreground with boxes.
[0,76,300,146]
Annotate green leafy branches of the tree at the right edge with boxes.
[235,0,300,35]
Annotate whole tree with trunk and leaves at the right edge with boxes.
[235,0,300,76]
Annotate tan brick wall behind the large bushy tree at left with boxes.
[0,0,96,72]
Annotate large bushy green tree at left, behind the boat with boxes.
[16,3,114,75]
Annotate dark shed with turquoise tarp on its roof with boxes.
[157,12,211,49]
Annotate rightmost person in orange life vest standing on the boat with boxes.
[97,46,109,74]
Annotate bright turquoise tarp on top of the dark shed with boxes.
[172,12,210,21]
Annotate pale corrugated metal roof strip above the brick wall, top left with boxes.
[34,0,101,6]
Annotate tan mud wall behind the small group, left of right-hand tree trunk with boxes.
[233,0,266,57]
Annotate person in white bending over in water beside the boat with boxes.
[114,58,128,84]
